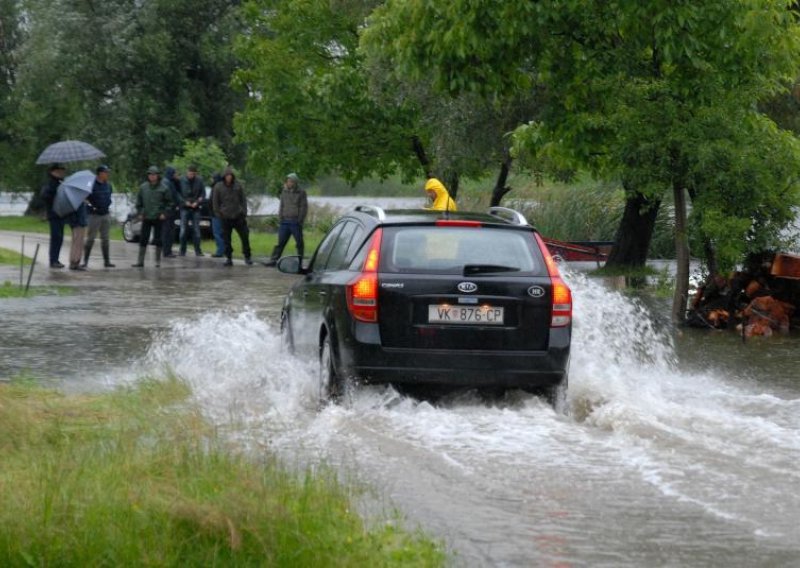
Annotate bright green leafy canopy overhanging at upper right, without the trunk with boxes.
[364,0,800,265]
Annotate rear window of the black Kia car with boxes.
[381,225,546,275]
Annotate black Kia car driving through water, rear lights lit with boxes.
[277,206,572,410]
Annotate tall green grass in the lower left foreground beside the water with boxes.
[0,379,445,566]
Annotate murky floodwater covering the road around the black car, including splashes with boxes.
[0,232,800,567]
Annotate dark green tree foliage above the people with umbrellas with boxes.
[0,0,241,192]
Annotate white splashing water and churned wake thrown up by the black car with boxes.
[141,273,800,559]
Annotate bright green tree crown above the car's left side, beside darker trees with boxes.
[234,0,422,182]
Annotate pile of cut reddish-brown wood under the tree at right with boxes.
[687,253,800,337]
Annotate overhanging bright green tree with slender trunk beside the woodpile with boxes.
[360,0,800,320]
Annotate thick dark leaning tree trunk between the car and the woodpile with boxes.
[606,183,661,267]
